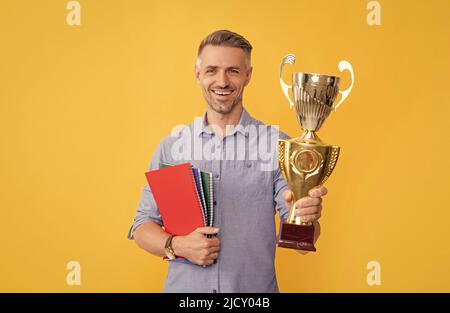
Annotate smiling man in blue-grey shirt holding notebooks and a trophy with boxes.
[129,30,327,292]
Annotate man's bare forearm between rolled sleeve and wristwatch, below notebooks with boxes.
[134,221,169,257]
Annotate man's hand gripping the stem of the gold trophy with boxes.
[283,186,328,222]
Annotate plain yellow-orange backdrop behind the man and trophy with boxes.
[0,0,450,292]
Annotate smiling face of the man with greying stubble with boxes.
[195,45,252,114]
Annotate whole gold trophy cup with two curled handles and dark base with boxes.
[277,54,354,251]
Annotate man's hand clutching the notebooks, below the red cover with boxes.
[172,227,220,265]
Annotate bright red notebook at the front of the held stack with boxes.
[145,163,204,236]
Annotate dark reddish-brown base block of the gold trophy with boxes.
[277,223,316,251]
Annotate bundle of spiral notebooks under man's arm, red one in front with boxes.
[145,163,214,262]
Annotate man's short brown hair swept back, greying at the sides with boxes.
[197,29,253,66]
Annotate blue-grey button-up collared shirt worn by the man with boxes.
[128,109,288,292]
